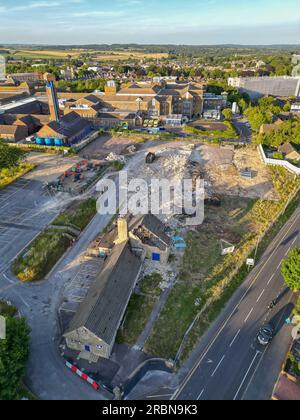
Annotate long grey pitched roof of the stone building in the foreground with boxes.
[66,242,142,344]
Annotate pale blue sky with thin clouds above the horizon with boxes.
[0,0,300,45]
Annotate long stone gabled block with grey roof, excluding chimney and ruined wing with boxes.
[64,240,142,362]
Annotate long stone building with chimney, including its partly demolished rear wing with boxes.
[64,214,171,362]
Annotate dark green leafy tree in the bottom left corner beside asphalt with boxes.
[0,317,29,400]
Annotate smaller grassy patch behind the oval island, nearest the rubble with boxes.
[52,198,97,230]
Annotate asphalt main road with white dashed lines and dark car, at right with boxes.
[172,209,300,400]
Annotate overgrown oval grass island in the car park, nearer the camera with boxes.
[13,229,71,282]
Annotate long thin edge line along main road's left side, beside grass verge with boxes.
[171,211,300,400]
